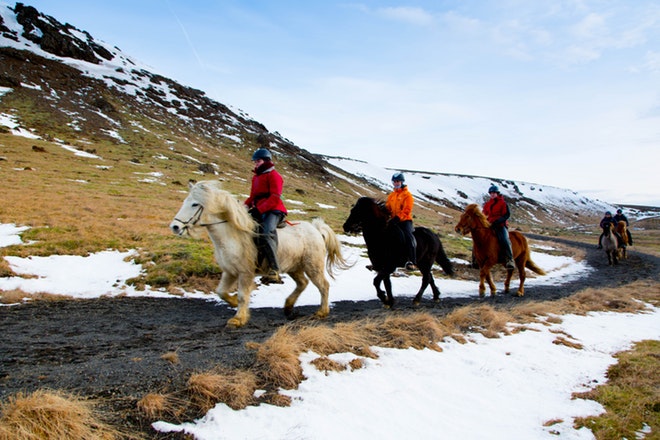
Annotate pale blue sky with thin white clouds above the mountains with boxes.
[10,0,660,206]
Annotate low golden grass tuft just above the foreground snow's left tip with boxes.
[188,370,257,412]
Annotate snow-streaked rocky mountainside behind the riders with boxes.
[0,3,660,226]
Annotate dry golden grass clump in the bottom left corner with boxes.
[0,390,125,440]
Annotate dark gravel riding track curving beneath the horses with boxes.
[0,234,660,438]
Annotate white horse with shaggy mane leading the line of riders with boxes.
[170,181,349,327]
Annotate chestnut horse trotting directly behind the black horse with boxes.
[455,203,545,296]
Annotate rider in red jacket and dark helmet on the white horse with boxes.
[245,148,287,284]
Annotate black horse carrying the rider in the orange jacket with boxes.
[344,197,454,307]
